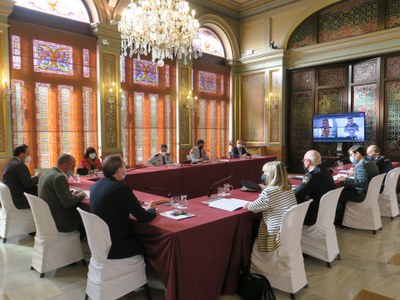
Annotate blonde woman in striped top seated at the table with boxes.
[244,161,297,256]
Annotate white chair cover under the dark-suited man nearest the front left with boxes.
[78,208,147,300]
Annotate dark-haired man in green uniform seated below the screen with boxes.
[335,145,379,225]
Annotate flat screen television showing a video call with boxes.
[313,112,365,143]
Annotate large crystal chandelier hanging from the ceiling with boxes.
[118,0,202,67]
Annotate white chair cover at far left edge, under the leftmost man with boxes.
[0,182,36,242]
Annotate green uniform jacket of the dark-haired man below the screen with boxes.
[344,158,379,198]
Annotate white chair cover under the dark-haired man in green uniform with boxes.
[342,173,386,233]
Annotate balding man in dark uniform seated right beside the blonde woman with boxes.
[294,150,335,225]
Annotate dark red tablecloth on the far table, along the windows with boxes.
[119,156,276,199]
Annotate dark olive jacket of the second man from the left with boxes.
[39,167,83,232]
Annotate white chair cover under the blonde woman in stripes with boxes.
[251,200,312,293]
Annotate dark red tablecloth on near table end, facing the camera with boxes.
[133,190,258,300]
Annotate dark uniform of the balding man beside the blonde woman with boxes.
[294,165,335,225]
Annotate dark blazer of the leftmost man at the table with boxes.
[3,157,39,209]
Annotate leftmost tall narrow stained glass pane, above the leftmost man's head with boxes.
[11,79,27,148]
